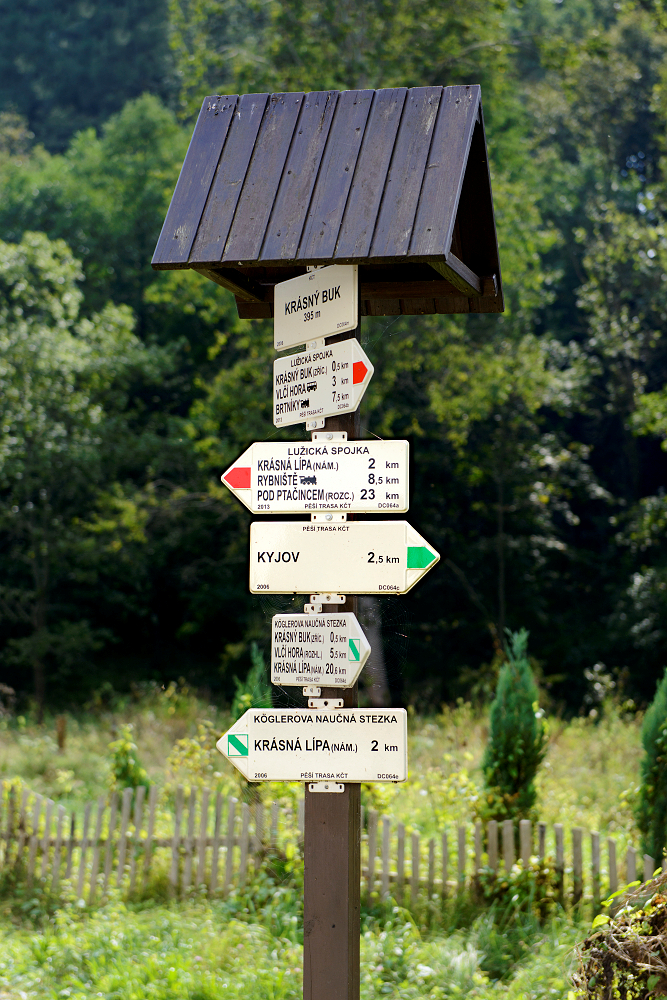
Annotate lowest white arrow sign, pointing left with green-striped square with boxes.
[216,708,408,782]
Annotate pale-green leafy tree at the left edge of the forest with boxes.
[0,233,171,714]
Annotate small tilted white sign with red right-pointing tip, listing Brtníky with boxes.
[273,338,374,427]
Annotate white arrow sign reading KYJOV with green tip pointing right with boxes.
[250,521,440,594]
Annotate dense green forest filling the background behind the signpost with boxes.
[0,0,667,711]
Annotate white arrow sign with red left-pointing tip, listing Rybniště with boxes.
[220,434,408,514]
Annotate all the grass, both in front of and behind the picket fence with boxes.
[0,685,641,1000]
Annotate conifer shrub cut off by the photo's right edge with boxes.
[637,670,667,865]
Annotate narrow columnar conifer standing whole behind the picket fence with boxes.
[478,629,548,820]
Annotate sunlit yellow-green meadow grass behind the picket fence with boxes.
[0,685,641,847]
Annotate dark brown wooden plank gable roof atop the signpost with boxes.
[152,86,503,319]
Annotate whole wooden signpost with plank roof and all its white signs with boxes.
[153,85,504,1000]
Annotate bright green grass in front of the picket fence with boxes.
[0,902,581,1000]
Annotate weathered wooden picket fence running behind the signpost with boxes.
[0,782,656,908]
